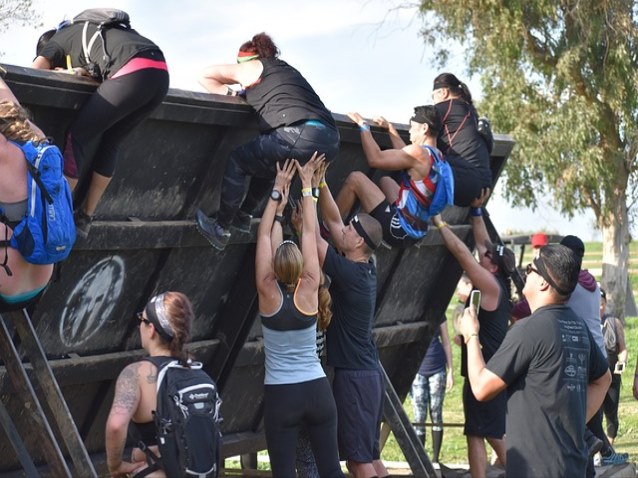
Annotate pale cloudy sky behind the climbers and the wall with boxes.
[0,0,600,240]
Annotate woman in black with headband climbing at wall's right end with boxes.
[432,73,492,206]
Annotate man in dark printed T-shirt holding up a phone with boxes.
[460,245,611,477]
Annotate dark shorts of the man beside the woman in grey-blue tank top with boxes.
[332,368,383,463]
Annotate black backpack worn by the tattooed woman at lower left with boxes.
[138,357,222,478]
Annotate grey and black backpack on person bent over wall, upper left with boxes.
[71,8,131,81]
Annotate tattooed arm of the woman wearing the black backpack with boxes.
[105,362,142,477]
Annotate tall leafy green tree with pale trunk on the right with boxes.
[420,0,638,316]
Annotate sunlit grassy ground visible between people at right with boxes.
[382,243,638,464]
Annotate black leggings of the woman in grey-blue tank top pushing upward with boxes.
[264,377,343,477]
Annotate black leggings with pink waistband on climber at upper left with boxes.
[64,68,169,179]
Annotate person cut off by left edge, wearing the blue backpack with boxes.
[0,78,53,312]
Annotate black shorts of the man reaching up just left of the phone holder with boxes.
[463,378,507,439]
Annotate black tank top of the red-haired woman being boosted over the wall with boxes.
[246,58,336,132]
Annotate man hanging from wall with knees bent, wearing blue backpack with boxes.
[336,106,454,248]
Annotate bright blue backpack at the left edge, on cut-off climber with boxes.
[0,141,75,275]
